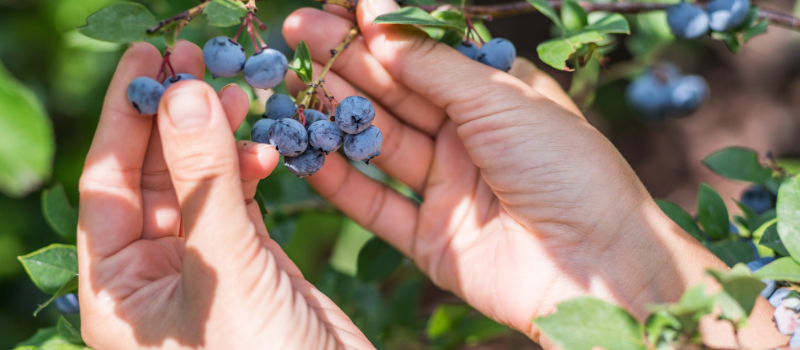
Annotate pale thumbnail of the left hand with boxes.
[167,86,211,131]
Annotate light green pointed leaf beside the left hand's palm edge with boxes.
[18,244,78,294]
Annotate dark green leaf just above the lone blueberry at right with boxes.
[703,147,772,184]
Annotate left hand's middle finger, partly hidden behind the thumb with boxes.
[141,40,205,239]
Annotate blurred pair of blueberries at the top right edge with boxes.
[667,0,750,39]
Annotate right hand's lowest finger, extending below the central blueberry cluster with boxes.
[306,153,419,258]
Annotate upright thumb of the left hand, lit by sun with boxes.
[158,80,255,265]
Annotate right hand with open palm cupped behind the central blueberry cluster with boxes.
[284,0,782,348]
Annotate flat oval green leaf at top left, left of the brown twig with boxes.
[78,2,156,44]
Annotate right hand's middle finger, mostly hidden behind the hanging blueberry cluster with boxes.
[286,62,433,193]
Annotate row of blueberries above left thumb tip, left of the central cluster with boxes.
[128,36,289,114]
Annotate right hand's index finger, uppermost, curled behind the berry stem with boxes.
[283,8,446,135]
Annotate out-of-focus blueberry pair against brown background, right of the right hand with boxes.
[625,62,708,121]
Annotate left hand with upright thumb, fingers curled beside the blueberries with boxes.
[78,41,373,349]
